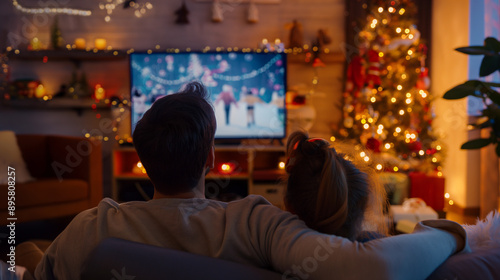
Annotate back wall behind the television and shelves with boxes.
[0,0,344,197]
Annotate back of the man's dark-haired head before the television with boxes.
[133,82,216,195]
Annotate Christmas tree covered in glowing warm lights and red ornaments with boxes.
[334,0,442,175]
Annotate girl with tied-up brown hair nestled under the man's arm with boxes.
[285,131,387,241]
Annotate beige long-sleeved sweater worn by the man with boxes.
[35,195,467,280]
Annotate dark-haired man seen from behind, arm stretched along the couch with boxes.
[35,82,468,280]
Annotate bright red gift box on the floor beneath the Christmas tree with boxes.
[408,172,444,211]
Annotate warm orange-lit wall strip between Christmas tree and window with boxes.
[431,0,472,207]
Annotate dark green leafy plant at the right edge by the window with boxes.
[443,37,500,157]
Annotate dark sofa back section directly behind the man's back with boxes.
[80,238,282,280]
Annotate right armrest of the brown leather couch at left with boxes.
[47,135,102,207]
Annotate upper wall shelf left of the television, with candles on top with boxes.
[8,50,127,62]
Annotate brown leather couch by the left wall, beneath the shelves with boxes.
[0,135,102,225]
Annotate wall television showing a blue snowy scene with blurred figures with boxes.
[130,52,286,139]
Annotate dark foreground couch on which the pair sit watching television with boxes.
[81,238,500,280]
